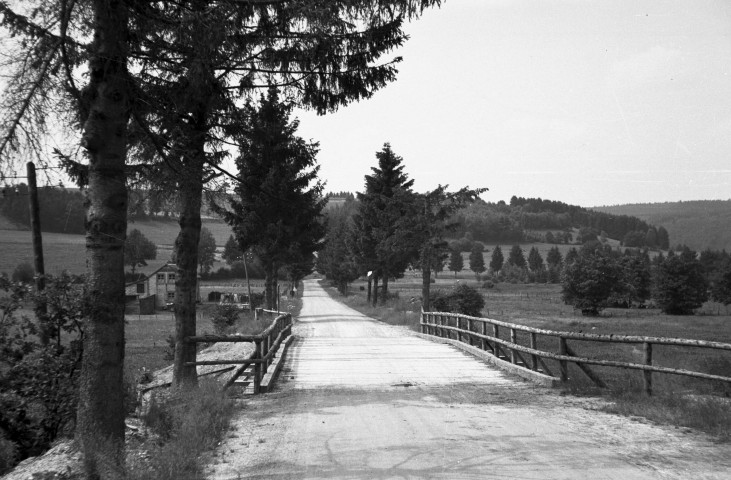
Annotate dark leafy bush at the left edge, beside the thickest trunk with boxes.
[0,275,85,468]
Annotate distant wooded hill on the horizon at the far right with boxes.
[592,200,731,251]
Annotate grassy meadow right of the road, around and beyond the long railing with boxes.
[323,276,731,441]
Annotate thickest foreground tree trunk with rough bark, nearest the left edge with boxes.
[76,0,130,479]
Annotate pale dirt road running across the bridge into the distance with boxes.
[210,282,731,480]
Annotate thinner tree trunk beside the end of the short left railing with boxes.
[173,154,205,388]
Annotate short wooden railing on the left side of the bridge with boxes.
[185,309,292,394]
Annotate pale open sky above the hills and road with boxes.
[295,0,731,207]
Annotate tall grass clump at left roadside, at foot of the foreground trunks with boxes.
[127,379,237,480]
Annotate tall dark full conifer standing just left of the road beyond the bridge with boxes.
[219,89,325,308]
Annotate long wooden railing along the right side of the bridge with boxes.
[420,312,731,395]
